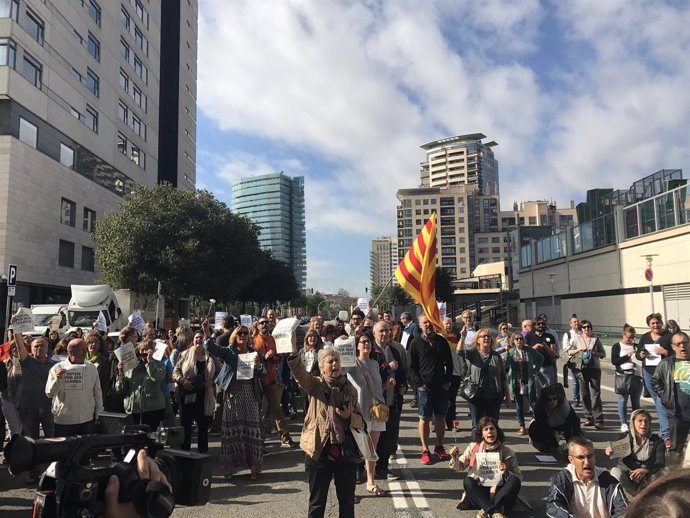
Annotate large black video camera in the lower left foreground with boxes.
[5,426,212,518]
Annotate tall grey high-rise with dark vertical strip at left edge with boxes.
[0,0,196,305]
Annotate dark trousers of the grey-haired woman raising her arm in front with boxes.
[305,458,358,518]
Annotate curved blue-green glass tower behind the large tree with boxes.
[232,172,307,290]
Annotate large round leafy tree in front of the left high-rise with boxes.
[92,183,260,300]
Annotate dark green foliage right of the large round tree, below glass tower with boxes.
[238,250,299,305]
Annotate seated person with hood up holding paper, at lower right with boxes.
[606,409,666,495]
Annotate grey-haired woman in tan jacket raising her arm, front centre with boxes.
[288,346,364,518]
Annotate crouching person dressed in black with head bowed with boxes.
[528,384,582,457]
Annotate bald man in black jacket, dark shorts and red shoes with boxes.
[408,315,453,464]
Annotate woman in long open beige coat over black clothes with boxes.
[173,332,216,453]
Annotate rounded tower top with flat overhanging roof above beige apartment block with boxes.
[420,133,499,196]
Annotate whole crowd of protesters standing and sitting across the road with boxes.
[0,309,690,518]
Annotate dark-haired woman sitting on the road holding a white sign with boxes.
[450,417,522,518]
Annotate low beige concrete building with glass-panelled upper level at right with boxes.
[519,173,690,333]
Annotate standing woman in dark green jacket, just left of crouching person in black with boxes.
[502,332,544,435]
